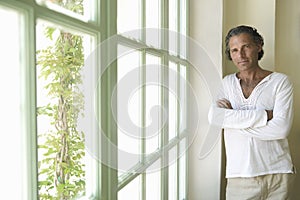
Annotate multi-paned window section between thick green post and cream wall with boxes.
[115,0,188,199]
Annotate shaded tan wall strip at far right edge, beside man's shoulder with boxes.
[275,0,300,199]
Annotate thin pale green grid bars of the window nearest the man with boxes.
[118,0,189,199]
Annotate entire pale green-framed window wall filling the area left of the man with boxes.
[0,0,188,200]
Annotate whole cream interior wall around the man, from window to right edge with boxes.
[188,0,300,200]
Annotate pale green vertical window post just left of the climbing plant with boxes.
[0,0,37,200]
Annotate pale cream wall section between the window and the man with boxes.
[188,0,223,200]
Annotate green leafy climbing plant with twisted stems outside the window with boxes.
[37,27,85,200]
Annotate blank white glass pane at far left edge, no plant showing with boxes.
[0,5,25,199]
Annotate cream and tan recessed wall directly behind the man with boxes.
[222,0,300,199]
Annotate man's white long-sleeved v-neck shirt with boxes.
[209,72,293,178]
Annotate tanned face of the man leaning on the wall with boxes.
[229,33,261,71]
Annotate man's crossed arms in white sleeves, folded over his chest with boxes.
[208,76,293,140]
